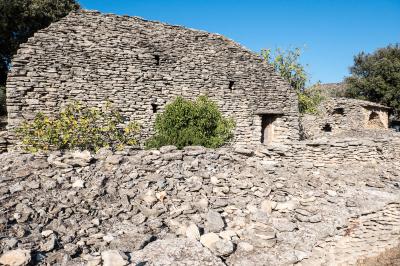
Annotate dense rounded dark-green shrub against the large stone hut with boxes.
[146,96,235,149]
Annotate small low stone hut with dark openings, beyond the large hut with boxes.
[301,98,390,139]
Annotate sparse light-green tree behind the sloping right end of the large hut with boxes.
[261,48,323,114]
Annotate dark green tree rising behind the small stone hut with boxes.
[346,44,400,115]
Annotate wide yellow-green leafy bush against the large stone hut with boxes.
[17,103,139,152]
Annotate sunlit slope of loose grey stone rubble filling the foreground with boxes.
[0,146,400,266]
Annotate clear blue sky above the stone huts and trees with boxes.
[79,0,400,83]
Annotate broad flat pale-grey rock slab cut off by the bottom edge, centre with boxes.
[130,236,225,266]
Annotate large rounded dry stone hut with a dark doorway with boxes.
[7,10,299,144]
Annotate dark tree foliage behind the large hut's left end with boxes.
[0,0,79,115]
